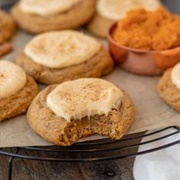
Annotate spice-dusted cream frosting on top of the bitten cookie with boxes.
[46,78,123,121]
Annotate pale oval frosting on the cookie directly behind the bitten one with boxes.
[24,30,101,68]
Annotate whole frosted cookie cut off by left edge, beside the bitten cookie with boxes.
[0,60,39,121]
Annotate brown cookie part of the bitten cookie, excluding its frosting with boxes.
[27,85,134,146]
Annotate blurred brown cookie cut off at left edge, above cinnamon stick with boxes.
[0,10,16,44]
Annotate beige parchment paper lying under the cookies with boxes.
[0,32,180,147]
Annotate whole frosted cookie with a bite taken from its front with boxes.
[27,78,134,146]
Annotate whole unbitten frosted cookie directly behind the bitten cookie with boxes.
[16,30,113,84]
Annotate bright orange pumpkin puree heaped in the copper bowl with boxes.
[112,7,180,50]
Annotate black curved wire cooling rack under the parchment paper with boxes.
[0,126,180,180]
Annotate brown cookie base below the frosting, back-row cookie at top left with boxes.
[11,0,95,33]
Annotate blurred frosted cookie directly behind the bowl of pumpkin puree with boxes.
[87,0,160,38]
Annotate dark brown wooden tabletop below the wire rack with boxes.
[0,148,134,180]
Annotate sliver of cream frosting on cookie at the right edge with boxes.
[171,63,180,89]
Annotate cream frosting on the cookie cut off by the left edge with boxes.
[0,60,26,99]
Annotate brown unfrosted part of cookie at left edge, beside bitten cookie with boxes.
[0,76,39,121]
